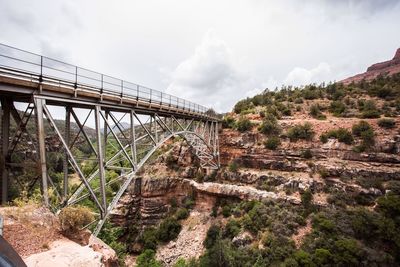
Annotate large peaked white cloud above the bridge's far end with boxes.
[167,30,248,111]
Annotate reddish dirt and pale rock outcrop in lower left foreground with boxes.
[0,204,118,267]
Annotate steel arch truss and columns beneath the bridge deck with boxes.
[0,95,219,235]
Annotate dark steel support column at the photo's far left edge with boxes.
[0,98,12,205]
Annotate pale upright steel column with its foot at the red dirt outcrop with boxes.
[34,98,49,207]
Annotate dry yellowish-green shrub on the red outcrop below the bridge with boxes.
[58,206,94,232]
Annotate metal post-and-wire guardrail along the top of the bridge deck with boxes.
[0,44,212,116]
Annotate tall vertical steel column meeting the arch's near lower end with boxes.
[94,106,107,218]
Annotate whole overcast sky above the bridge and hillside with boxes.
[0,0,400,112]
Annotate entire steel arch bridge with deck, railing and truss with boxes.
[0,44,219,234]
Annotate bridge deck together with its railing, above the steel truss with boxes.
[0,44,216,120]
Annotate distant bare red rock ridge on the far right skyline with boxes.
[340,48,400,84]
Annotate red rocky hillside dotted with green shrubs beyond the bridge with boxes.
[112,70,400,266]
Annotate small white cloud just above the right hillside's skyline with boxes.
[283,62,332,86]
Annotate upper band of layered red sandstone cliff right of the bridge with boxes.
[220,129,400,180]
